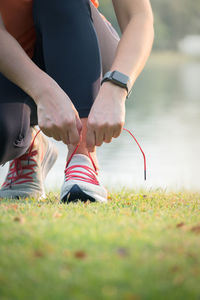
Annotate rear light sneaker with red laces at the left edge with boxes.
[0,131,57,199]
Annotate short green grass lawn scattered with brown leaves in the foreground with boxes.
[0,191,200,300]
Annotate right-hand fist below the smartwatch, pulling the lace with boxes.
[87,82,127,152]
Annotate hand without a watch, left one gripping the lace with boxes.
[34,82,82,145]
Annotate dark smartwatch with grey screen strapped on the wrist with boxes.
[101,71,131,98]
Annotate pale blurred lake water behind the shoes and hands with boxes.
[0,59,200,190]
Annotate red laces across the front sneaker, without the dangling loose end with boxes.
[65,145,99,185]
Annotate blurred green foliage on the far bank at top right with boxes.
[100,0,200,50]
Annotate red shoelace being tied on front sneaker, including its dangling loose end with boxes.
[65,128,146,185]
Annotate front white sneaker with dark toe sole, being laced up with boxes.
[61,154,107,203]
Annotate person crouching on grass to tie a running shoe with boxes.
[0,0,153,202]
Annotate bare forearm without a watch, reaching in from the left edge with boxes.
[0,26,53,101]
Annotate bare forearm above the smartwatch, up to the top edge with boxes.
[112,0,154,84]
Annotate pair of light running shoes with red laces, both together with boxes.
[0,128,146,203]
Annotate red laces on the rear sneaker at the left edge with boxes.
[2,130,40,187]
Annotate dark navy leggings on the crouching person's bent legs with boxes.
[0,0,118,164]
